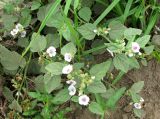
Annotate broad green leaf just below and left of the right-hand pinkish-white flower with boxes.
[113,54,130,73]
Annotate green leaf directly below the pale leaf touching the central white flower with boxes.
[44,76,61,93]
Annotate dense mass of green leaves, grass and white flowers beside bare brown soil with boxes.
[0,0,158,119]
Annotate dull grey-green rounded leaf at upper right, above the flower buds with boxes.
[109,21,126,40]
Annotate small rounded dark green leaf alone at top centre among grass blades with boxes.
[78,7,92,22]
